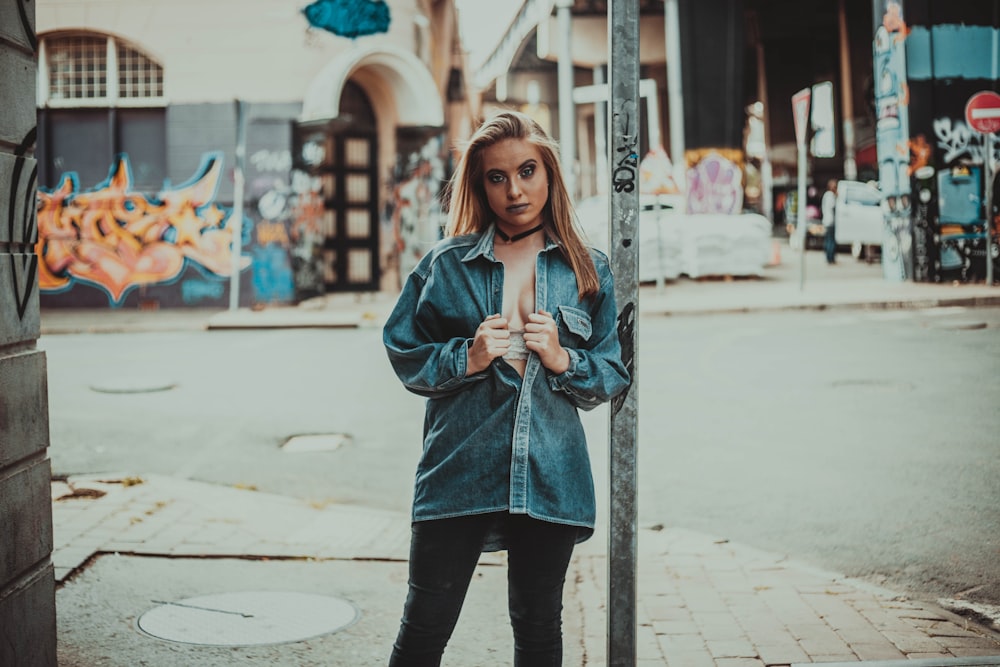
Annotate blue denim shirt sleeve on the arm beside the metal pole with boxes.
[549,265,631,410]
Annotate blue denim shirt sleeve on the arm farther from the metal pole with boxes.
[382,262,487,398]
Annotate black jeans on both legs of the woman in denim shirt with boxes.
[389,513,577,667]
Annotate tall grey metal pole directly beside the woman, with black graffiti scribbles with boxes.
[607,0,641,667]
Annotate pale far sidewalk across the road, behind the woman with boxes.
[41,250,1000,334]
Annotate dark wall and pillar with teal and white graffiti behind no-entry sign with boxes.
[875,0,1000,282]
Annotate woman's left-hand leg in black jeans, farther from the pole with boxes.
[389,515,490,667]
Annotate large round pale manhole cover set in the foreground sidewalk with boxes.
[138,591,358,646]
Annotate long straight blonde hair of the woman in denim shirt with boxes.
[445,111,600,299]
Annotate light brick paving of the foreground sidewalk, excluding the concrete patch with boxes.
[52,477,1000,667]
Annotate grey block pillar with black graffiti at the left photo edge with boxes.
[0,0,56,667]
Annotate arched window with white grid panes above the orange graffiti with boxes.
[37,32,166,189]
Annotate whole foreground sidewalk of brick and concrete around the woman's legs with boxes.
[52,476,1000,667]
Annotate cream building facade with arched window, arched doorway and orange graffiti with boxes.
[31,0,472,308]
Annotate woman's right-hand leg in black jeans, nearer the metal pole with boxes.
[507,515,577,667]
